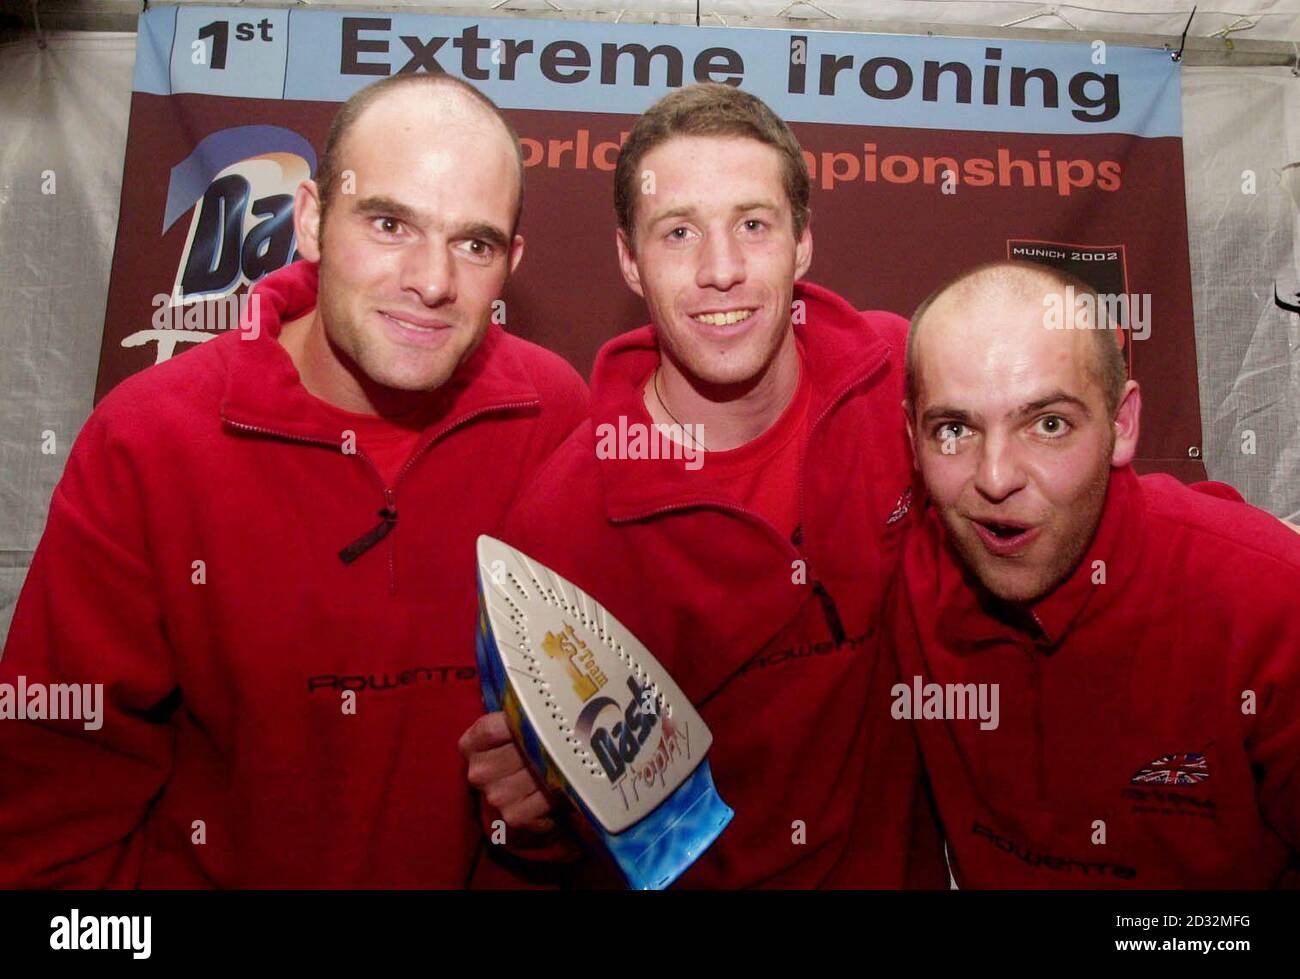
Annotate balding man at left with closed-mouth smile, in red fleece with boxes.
[0,75,586,887]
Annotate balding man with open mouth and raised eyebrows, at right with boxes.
[889,263,1300,888]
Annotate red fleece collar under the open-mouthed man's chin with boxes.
[924,465,1144,653]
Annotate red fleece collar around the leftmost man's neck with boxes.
[221,261,541,443]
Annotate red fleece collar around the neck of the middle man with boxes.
[592,282,891,523]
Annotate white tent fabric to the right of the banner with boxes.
[1190,68,1300,523]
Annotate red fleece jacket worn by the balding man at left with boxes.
[0,263,588,887]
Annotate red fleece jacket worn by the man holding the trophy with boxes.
[503,283,946,888]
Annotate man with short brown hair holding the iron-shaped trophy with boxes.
[462,85,946,887]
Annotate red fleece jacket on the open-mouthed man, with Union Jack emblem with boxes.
[891,468,1300,888]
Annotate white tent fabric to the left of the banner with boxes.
[0,34,135,634]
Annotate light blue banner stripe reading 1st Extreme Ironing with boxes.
[135,7,1182,137]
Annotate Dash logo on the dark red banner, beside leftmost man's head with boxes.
[122,126,316,363]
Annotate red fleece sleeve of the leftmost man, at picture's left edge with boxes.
[0,408,177,888]
